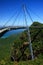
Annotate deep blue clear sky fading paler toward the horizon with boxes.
[0,0,43,26]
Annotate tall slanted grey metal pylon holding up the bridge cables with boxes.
[23,5,34,60]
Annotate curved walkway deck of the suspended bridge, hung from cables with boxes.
[0,26,43,37]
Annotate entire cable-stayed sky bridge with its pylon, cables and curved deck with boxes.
[0,5,43,60]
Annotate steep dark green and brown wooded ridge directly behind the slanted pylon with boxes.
[10,22,43,60]
